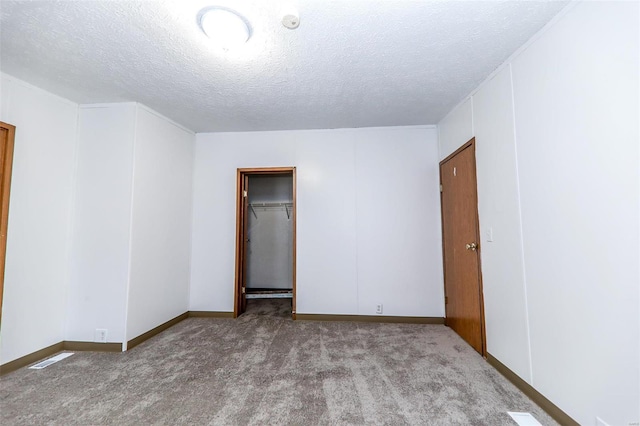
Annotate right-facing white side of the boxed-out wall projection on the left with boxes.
[127,105,194,340]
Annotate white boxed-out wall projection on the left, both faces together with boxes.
[65,103,194,343]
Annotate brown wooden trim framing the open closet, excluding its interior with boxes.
[233,167,298,319]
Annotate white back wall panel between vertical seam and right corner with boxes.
[356,136,444,317]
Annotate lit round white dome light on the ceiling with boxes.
[198,6,251,48]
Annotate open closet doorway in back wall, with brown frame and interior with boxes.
[233,167,296,319]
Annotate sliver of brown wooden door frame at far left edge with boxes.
[0,121,16,324]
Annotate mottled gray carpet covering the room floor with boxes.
[0,299,556,425]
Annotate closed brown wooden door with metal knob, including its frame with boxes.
[440,139,485,355]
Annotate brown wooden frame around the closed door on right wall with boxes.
[438,137,487,358]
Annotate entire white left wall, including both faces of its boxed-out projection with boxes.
[0,90,194,356]
